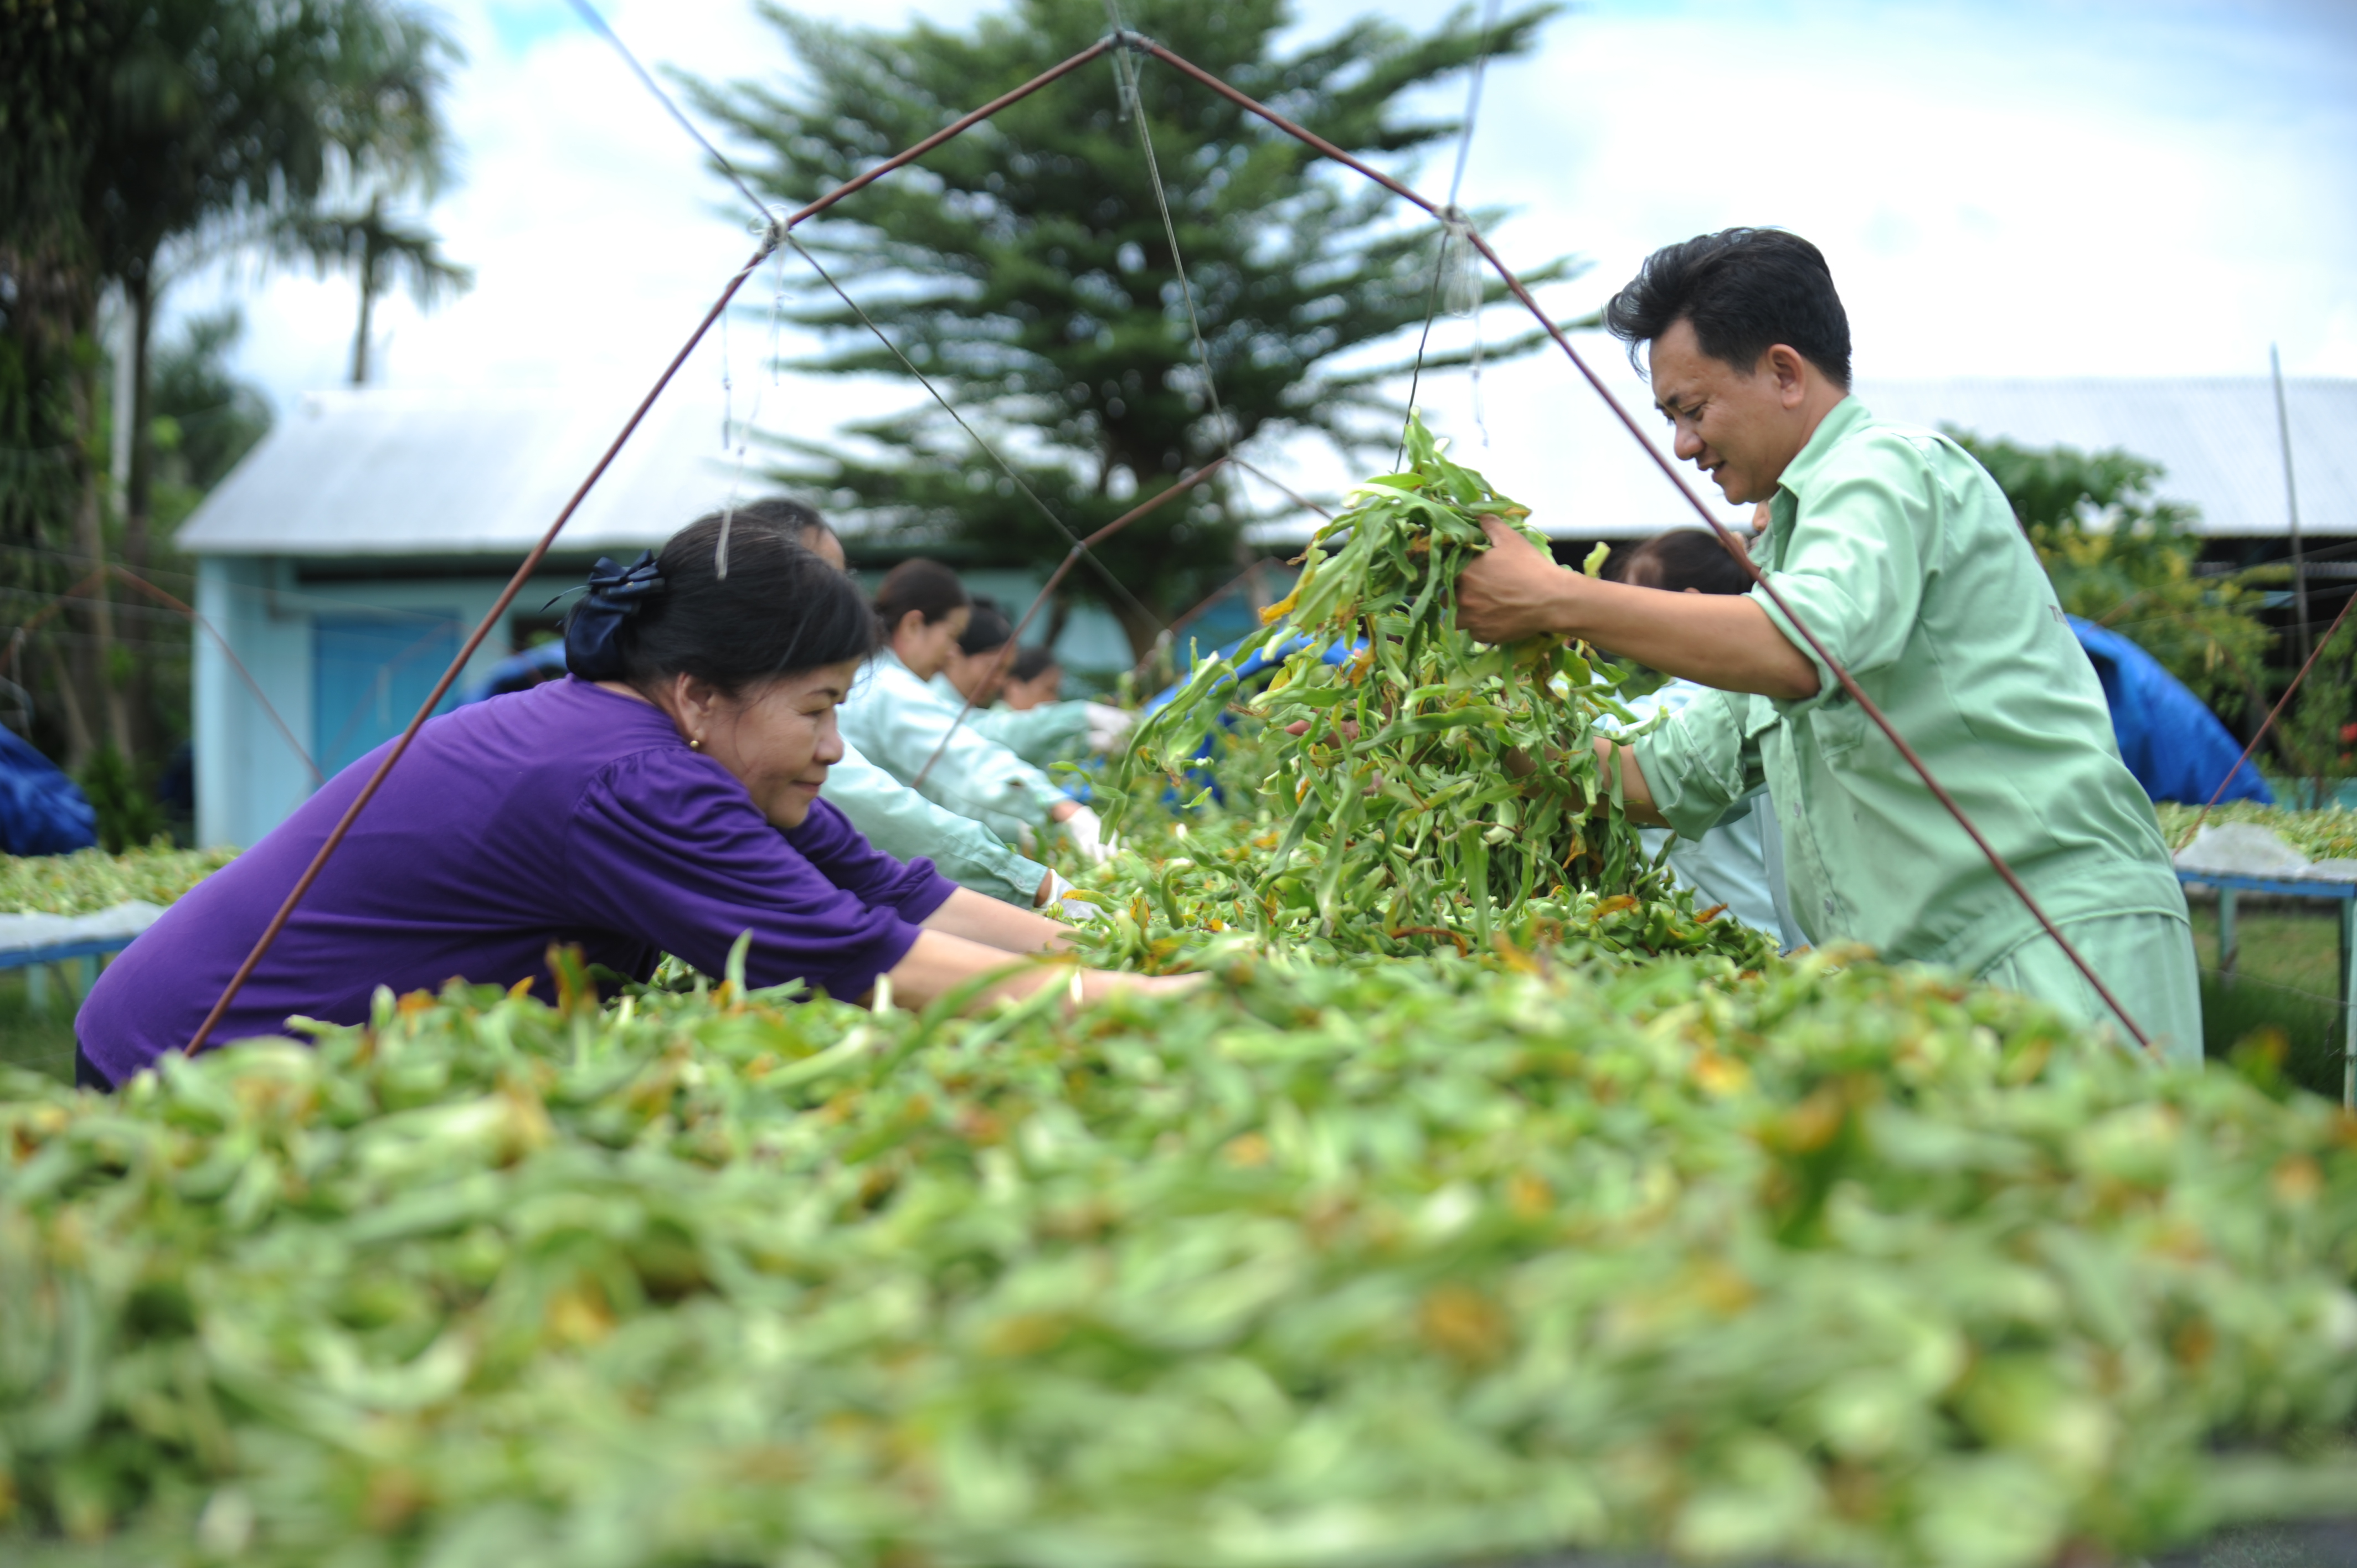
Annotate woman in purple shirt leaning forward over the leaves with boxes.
[75,519,1183,1087]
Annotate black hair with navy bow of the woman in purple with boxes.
[565,512,877,695]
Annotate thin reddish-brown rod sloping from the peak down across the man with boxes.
[1139,40,2159,1054]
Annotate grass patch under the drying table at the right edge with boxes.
[2192,901,2343,1099]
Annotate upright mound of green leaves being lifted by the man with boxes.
[1105,422,1761,957]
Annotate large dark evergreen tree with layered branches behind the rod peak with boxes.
[688,0,1572,653]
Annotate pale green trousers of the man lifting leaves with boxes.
[1975,915,2201,1068]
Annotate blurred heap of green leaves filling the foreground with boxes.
[0,955,2357,1568]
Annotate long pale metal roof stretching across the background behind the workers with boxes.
[179,344,2357,559]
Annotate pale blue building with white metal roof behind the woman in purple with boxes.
[179,365,1129,844]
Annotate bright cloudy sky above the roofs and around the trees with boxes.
[179,0,2357,525]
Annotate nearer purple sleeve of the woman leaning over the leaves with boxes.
[565,752,948,997]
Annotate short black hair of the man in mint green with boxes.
[1605,229,1850,389]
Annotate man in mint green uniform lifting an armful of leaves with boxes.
[1459,229,2201,1064]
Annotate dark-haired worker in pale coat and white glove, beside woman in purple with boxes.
[841,559,1105,860]
